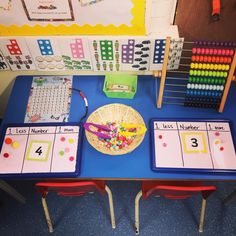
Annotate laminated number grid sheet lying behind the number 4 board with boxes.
[25,76,72,123]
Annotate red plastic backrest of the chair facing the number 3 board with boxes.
[142,181,216,199]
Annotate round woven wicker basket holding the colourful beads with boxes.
[85,103,145,155]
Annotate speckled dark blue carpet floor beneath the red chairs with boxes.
[0,181,236,236]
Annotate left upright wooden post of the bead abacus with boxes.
[157,37,171,108]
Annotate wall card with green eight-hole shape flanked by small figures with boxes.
[89,37,121,71]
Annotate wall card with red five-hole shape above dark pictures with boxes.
[0,37,35,70]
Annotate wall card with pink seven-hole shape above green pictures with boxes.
[57,37,93,70]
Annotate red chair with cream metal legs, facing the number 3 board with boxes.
[135,181,216,234]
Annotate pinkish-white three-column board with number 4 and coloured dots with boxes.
[0,124,82,177]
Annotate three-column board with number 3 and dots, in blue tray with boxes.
[151,119,236,171]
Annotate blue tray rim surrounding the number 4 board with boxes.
[0,122,84,178]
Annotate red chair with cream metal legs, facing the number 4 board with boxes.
[36,180,116,233]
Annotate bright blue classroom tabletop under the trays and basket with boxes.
[3,76,236,180]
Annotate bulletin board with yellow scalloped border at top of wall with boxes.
[0,0,146,36]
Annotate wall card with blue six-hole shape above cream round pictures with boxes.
[26,37,65,71]
